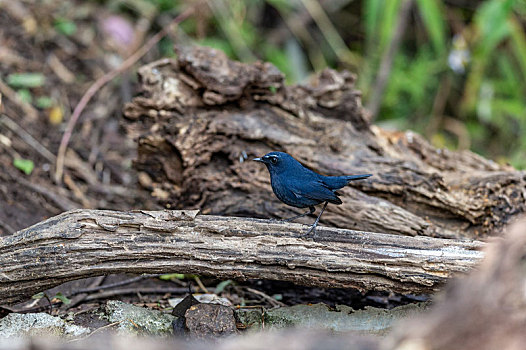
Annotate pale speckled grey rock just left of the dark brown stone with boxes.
[104,300,176,336]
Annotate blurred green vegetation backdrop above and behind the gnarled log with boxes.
[4,0,526,169]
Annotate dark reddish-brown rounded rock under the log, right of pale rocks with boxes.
[185,304,237,338]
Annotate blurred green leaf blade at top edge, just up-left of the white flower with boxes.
[417,0,446,54]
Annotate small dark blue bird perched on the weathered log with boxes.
[253,152,372,236]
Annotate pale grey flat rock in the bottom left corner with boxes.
[0,313,91,338]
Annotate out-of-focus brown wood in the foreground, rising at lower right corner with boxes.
[4,216,526,350]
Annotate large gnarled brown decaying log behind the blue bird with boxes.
[125,48,526,238]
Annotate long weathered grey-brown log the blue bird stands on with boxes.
[0,210,482,304]
